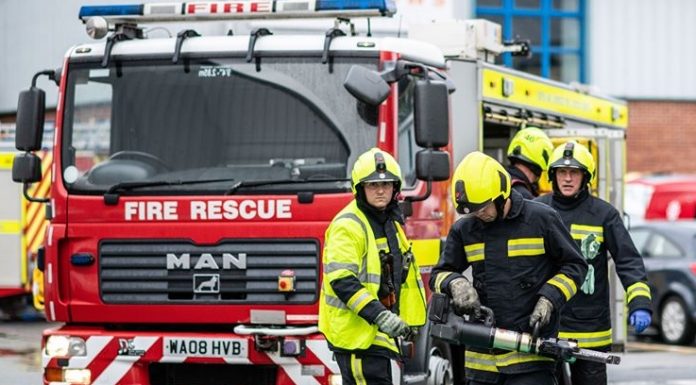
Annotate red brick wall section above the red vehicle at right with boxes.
[627,101,696,173]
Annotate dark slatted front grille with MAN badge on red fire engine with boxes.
[99,240,319,304]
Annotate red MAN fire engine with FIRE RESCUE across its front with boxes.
[13,0,626,385]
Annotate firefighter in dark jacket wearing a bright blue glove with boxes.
[537,141,651,385]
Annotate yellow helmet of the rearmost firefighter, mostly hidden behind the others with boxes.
[507,127,553,176]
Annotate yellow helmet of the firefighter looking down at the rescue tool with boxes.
[452,151,510,216]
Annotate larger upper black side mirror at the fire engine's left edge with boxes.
[13,87,46,152]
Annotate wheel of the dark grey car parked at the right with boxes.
[660,296,696,345]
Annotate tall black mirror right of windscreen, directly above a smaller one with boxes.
[414,80,449,148]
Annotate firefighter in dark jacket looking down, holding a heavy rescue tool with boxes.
[430,152,587,385]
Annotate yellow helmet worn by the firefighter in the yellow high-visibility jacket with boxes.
[351,148,401,195]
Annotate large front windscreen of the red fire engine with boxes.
[62,57,377,194]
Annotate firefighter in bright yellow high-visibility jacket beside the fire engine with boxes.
[319,148,426,385]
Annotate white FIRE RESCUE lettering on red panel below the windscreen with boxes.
[124,199,292,221]
